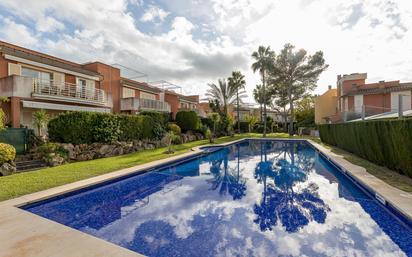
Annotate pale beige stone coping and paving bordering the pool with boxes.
[0,137,412,256]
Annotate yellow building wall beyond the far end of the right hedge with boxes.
[315,86,338,124]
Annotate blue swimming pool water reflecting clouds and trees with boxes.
[24,140,412,256]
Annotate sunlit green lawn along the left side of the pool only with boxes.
[0,133,288,201]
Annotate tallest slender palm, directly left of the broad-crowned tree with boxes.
[252,46,275,137]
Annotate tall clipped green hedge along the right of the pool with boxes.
[319,119,412,177]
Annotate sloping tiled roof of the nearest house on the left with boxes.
[0,41,100,76]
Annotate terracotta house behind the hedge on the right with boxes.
[329,73,412,122]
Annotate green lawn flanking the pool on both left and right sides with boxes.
[0,133,412,201]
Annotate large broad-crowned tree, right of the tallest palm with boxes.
[269,44,328,135]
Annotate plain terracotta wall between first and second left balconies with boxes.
[83,62,122,113]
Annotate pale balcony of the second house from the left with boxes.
[120,97,170,112]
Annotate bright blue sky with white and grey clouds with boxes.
[0,0,412,102]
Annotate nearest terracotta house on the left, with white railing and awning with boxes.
[0,42,113,130]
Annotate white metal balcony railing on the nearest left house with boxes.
[32,79,108,105]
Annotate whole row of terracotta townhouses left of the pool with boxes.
[0,41,199,128]
